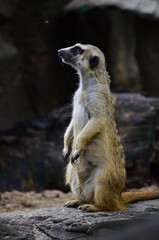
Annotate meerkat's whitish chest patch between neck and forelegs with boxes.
[73,92,89,134]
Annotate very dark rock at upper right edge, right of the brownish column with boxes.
[136,16,159,96]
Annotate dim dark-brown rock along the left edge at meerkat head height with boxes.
[0,35,33,130]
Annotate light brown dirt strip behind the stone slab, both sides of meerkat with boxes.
[0,185,159,213]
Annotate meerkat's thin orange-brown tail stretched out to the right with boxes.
[122,192,159,204]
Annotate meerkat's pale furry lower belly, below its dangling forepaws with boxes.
[67,136,106,203]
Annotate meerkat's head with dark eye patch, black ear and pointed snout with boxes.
[58,43,105,71]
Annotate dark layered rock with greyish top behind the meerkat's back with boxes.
[114,94,159,187]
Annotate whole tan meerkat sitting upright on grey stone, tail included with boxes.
[58,43,159,212]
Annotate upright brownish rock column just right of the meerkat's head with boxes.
[104,9,140,91]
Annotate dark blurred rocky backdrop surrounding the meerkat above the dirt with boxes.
[0,0,159,208]
